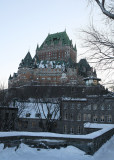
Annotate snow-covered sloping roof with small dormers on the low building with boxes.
[16,102,60,119]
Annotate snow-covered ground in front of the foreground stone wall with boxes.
[0,136,114,160]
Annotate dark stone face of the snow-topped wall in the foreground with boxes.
[0,129,114,155]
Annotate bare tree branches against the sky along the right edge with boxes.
[81,0,114,87]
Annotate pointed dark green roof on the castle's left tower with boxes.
[19,52,33,67]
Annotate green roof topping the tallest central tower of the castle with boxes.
[39,31,72,49]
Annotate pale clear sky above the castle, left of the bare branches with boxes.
[0,0,104,85]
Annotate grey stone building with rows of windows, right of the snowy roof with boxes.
[61,95,114,134]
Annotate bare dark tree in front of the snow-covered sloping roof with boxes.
[35,99,61,132]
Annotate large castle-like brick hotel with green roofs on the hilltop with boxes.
[8,31,97,88]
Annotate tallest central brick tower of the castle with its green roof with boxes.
[36,31,77,63]
